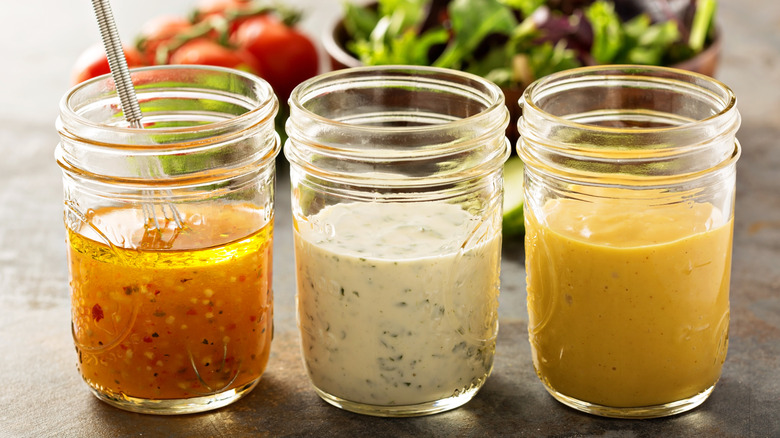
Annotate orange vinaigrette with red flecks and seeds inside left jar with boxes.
[68,205,273,399]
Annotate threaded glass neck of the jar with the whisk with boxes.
[55,65,281,187]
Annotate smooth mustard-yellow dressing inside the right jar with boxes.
[526,199,733,407]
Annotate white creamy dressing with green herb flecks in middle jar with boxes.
[295,202,501,406]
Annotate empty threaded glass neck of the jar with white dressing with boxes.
[284,65,511,187]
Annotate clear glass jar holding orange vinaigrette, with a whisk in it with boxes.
[56,66,281,414]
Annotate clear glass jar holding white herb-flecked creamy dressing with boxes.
[285,67,510,416]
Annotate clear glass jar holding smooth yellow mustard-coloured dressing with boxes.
[517,66,740,418]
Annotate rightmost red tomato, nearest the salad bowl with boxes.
[232,14,319,101]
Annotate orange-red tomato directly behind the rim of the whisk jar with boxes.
[169,38,262,75]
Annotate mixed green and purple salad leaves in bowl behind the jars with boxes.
[343,0,717,87]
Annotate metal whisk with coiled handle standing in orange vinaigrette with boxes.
[92,0,184,230]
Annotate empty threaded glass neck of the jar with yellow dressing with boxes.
[517,65,741,185]
